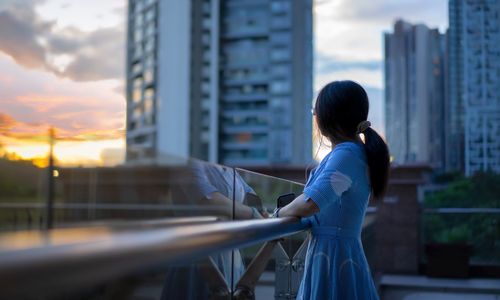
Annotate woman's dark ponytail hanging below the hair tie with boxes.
[363,127,389,198]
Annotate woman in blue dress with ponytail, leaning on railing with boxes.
[275,81,389,299]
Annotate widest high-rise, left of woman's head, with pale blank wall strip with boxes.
[127,0,312,166]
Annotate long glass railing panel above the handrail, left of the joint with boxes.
[0,156,239,232]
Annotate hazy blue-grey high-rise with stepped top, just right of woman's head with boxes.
[384,20,445,169]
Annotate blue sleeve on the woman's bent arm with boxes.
[304,149,355,210]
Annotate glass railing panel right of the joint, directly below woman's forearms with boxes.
[233,169,307,299]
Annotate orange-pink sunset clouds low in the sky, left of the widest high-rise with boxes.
[0,54,125,144]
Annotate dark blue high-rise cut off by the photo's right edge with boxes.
[446,0,500,175]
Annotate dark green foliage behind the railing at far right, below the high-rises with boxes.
[422,173,500,264]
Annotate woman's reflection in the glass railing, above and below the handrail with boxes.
[162,160,270,299]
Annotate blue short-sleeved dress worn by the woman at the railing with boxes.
[297,142,379,300]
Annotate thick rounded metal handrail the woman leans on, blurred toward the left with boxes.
[0,218,308,298]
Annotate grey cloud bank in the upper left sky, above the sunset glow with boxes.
[0,1,125,81]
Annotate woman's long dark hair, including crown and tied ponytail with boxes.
[314,80,389,198]
